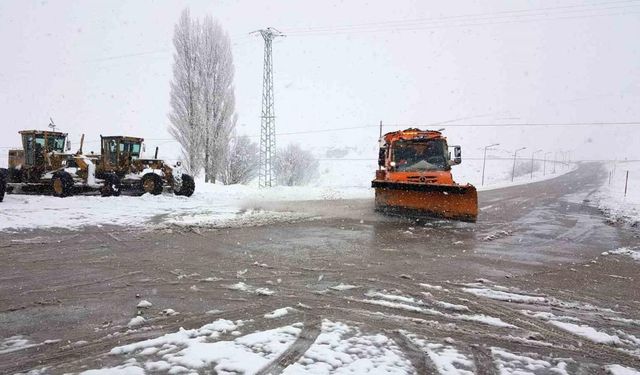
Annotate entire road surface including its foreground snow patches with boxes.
[0,164,640,374]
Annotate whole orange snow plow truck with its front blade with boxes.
[371,128,478,222]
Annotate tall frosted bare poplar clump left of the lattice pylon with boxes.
[169,9,237,182]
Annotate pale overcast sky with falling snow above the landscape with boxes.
[0,0,640,164]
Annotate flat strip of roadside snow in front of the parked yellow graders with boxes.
[0,191,307,230]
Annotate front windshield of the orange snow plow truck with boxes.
[393,139,450,172]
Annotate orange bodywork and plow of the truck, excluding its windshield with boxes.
[372,129,478,222]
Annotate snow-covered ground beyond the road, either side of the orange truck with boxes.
[0,150,576,230]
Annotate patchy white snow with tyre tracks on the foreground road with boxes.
[45,280,640,375]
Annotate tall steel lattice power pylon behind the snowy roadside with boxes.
[252,27,284,187]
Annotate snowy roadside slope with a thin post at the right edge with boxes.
[592,161,640,224]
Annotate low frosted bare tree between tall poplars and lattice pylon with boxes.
[220,135,260,185]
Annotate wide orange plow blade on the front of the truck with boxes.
[371,180,478,222]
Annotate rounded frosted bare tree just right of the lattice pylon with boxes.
[275,144,318,186]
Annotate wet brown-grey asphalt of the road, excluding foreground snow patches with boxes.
[0,164,640,373]
